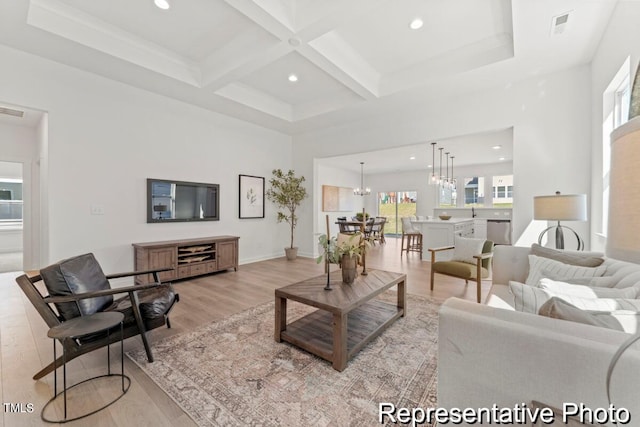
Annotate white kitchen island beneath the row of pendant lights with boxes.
[411,218,473,261]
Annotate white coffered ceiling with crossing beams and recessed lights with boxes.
[0,0,623,134]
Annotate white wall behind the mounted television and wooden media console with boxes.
[0,47,292,272]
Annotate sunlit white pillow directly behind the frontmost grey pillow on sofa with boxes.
[509,281,640,313]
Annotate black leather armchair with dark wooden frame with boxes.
[16,253,179,380]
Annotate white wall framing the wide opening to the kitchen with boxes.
[293,66,591,254]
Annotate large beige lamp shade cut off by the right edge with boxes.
[606,116,640,263]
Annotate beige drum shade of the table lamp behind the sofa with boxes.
[533,193,587,221]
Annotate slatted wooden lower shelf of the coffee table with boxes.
[280,301,404,370]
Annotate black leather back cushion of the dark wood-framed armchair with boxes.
[40,253,113,320]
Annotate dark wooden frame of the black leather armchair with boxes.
[16,268,179,380]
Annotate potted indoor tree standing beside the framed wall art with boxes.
[266,169,307,260]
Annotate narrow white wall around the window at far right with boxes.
[591,0,640,251]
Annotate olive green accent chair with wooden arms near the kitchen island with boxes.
[429,240,494,302]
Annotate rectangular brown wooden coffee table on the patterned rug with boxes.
[274,270,407,371]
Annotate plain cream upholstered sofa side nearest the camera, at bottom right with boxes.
[438,298,640,420]
